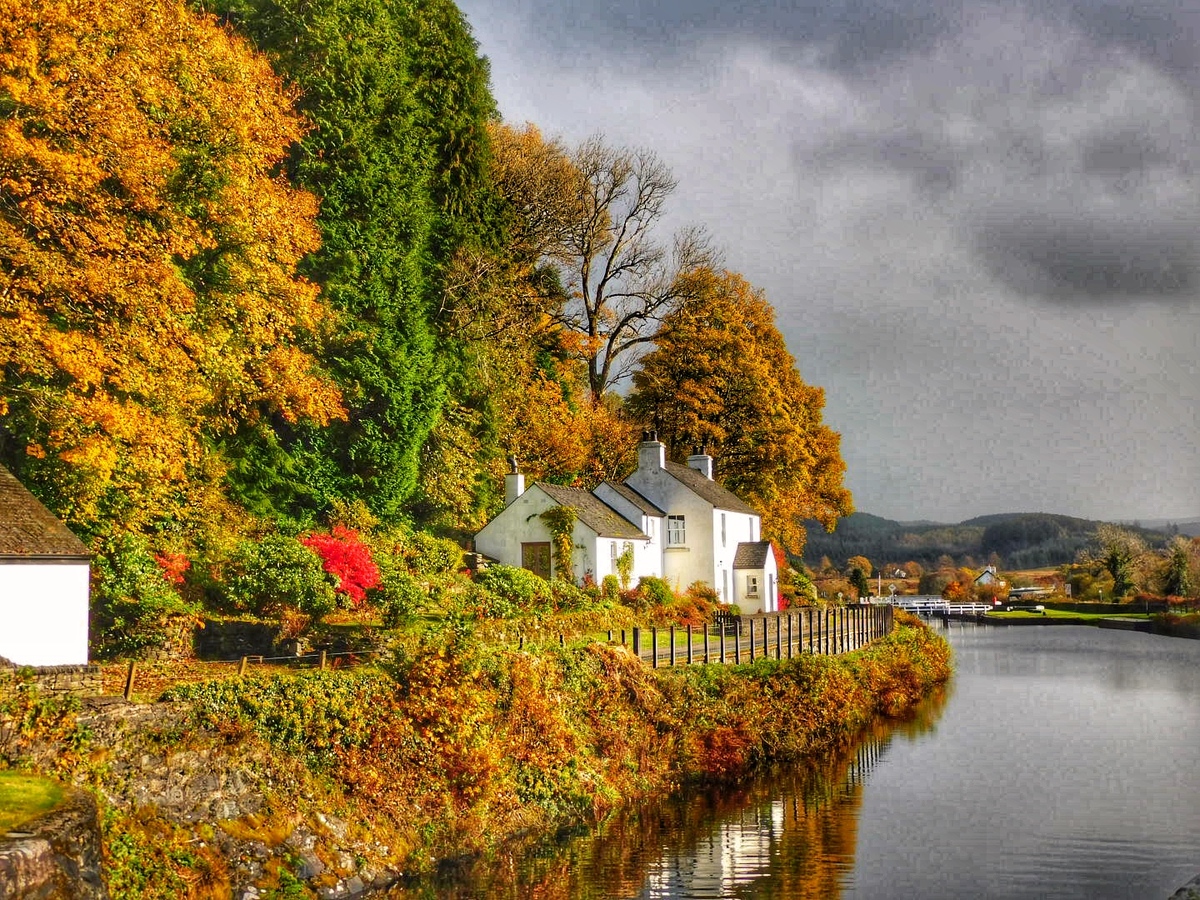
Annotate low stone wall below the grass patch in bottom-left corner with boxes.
[0,790,108,900]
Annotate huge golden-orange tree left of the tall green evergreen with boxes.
[0,0,343,533]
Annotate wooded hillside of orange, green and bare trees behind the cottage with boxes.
[0,0,852,643]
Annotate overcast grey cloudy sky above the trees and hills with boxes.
[460,0,1200,522]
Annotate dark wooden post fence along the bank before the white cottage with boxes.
[608,605,893,668]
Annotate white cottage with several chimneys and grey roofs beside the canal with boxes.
[475,436,779,612]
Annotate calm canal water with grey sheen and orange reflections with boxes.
[390,625,1200,900]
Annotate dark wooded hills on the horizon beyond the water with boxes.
[804,512,1166,569]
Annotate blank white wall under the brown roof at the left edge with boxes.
[0,559,91,666]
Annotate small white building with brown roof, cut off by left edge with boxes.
[0,466,91,666]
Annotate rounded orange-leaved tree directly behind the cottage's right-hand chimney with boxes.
[628,268,853,556]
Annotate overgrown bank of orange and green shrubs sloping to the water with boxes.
[0,623,950,898]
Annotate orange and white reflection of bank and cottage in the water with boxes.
[386,691,949,900]
